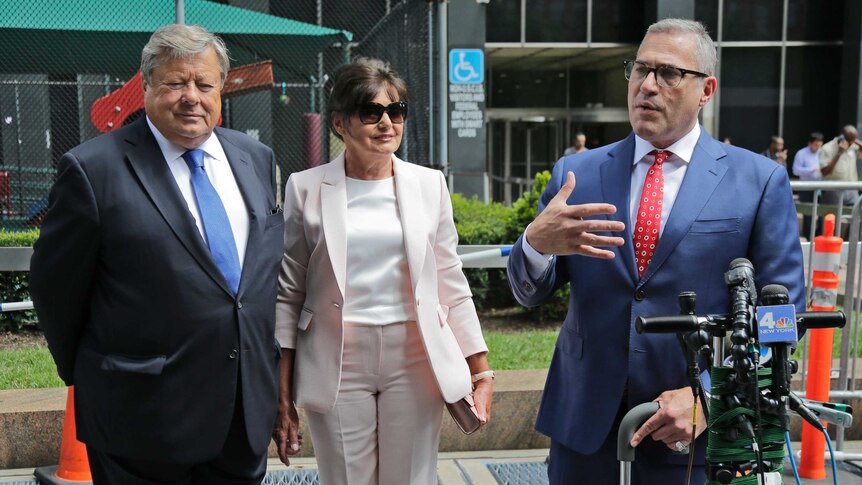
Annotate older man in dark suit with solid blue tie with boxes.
[30,25,284,484]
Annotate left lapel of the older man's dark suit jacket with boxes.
[126,116,233,296]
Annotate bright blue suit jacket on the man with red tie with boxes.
[508,130,804,458]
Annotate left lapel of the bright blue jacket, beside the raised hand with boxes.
[604,133,638,284]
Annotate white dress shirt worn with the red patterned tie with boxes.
[522,124,700,279]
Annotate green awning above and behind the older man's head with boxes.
[0,0,352,81]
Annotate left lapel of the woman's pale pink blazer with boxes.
[320,152,347,298]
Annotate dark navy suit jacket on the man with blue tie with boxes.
[30,117,284,463]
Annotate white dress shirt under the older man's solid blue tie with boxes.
[147,117,249,269]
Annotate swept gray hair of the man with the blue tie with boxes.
[141,24,230,88]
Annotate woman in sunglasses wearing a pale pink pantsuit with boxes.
[273,59,493,485]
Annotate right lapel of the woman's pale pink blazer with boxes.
[392,155,426,293]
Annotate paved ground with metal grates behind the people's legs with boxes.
[0,442,862,485]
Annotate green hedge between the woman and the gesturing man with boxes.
[452,171,568,320]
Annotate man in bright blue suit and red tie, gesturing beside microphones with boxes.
[508,19,804,485]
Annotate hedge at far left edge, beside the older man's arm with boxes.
[0,229,39,332]
